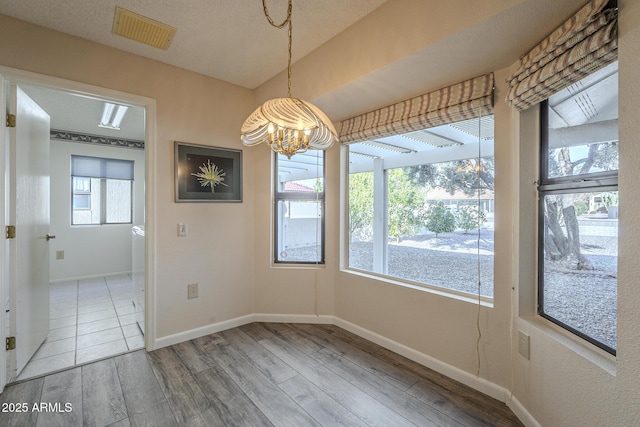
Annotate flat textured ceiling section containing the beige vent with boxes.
[0,0,386,89]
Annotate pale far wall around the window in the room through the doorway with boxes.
[49,140,145,282]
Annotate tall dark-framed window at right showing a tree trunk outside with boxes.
[538,62,619,354]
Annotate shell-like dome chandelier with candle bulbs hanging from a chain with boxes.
[240,0,338,158]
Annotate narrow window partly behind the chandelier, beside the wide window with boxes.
[274,150,325,264]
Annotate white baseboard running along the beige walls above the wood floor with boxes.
[154,313,540,427]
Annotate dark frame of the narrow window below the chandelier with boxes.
[273,150,327,266]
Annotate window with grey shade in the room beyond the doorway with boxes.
[71,156,133,225]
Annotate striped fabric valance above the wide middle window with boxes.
[339,73,493,144]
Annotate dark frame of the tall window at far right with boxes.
[536,99,619,356]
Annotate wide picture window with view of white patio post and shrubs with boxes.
[348,115,494,298]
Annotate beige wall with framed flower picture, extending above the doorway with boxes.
[0,15,257,339]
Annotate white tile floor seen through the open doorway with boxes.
[17,275,144,380]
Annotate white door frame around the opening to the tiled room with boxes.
[0,66,157,393]
